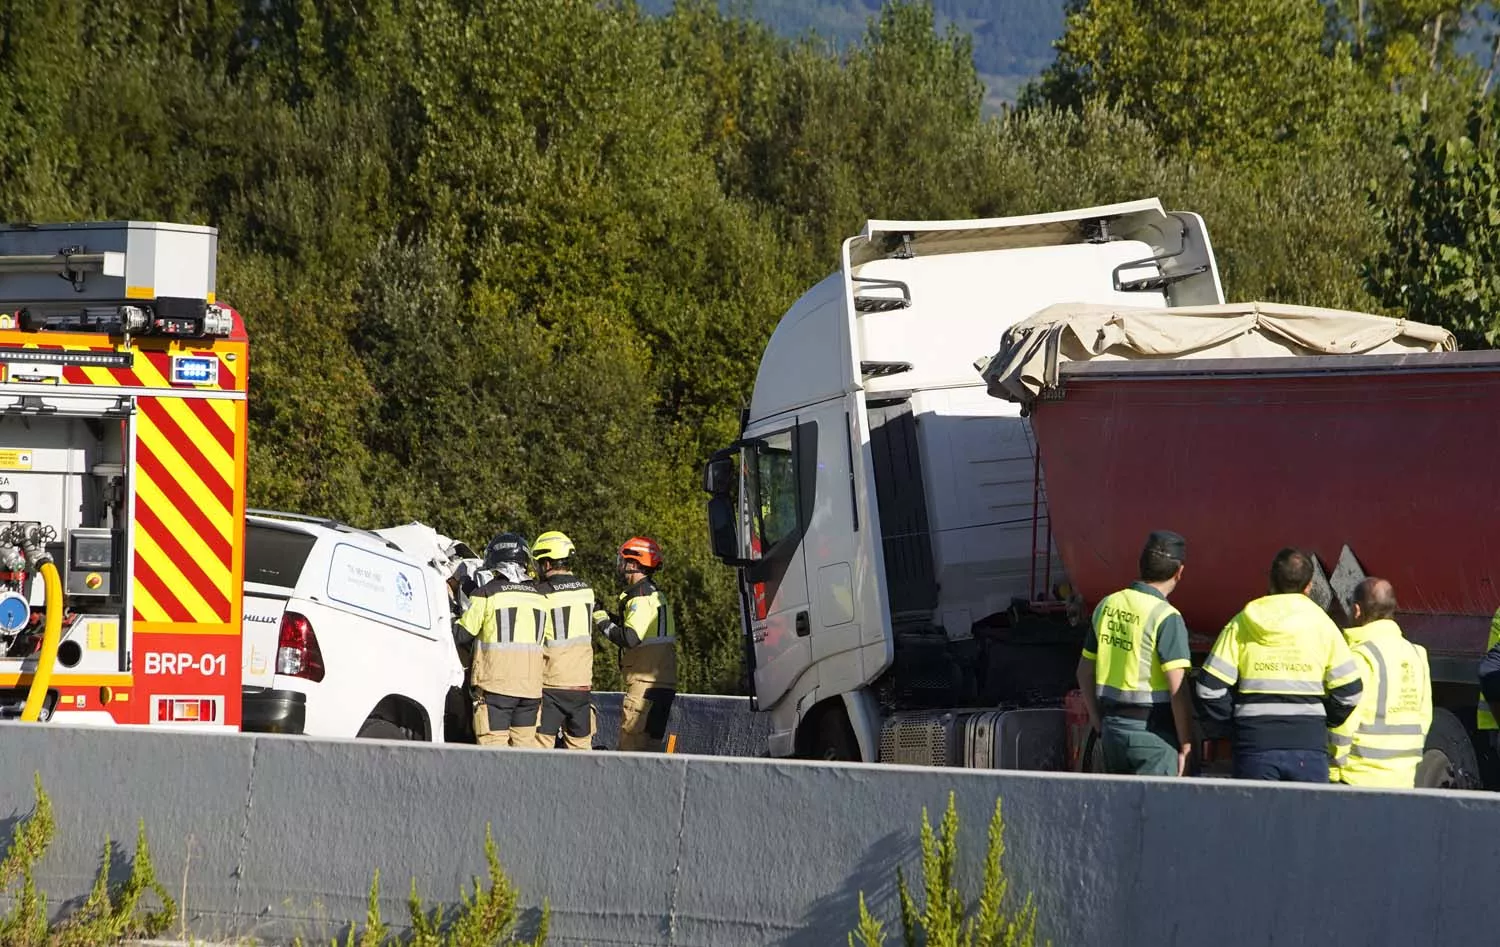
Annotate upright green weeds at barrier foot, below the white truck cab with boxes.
[849,792,1052,947]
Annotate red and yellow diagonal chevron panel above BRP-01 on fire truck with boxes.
[133,396,245,624]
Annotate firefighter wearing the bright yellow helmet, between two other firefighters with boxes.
[531,530,594,750]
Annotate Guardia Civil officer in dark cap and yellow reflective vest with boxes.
[1079,530,1193,776]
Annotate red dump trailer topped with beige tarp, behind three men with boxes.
[986,303,1500,786]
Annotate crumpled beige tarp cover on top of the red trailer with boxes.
[975,303,1457,405]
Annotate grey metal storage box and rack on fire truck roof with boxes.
[0,221,219,306]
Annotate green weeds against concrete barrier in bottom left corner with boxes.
[0,774,177,947]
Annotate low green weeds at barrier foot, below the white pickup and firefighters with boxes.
[294,825,552,947]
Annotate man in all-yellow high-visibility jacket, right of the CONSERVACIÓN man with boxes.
[1329,578,1433,789]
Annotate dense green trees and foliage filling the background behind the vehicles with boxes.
[0,0,1500,690]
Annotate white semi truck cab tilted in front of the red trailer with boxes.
[704,198,1224,768]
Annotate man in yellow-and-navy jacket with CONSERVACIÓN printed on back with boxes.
[1194,548,1364,782]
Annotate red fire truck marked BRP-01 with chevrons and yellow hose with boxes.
[0,221,249,729]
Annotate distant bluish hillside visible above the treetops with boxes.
[641,0,1064,110]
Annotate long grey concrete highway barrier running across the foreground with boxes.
[0,723,1500,947]
